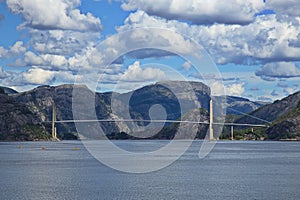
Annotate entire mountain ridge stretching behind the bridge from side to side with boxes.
[2,81,300,140]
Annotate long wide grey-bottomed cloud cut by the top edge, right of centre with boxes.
[122,0,264,24]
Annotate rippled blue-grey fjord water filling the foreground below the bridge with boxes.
[0,140,300,200]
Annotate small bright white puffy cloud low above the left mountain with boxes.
[23,68,55,84]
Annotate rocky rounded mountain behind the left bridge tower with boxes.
[13,84,118,139]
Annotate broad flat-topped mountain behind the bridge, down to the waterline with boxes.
[108,81,210,139]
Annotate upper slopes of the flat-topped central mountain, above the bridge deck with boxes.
[119,81,210,120]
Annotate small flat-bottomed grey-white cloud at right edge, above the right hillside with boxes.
[255,62,300,78]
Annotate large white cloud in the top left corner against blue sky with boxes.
[6,0,101,31]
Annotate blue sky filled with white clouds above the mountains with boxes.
[0,0,300,101]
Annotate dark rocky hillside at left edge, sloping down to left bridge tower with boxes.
[0,94,50,141]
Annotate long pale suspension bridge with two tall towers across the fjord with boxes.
[47,99,270,141]
